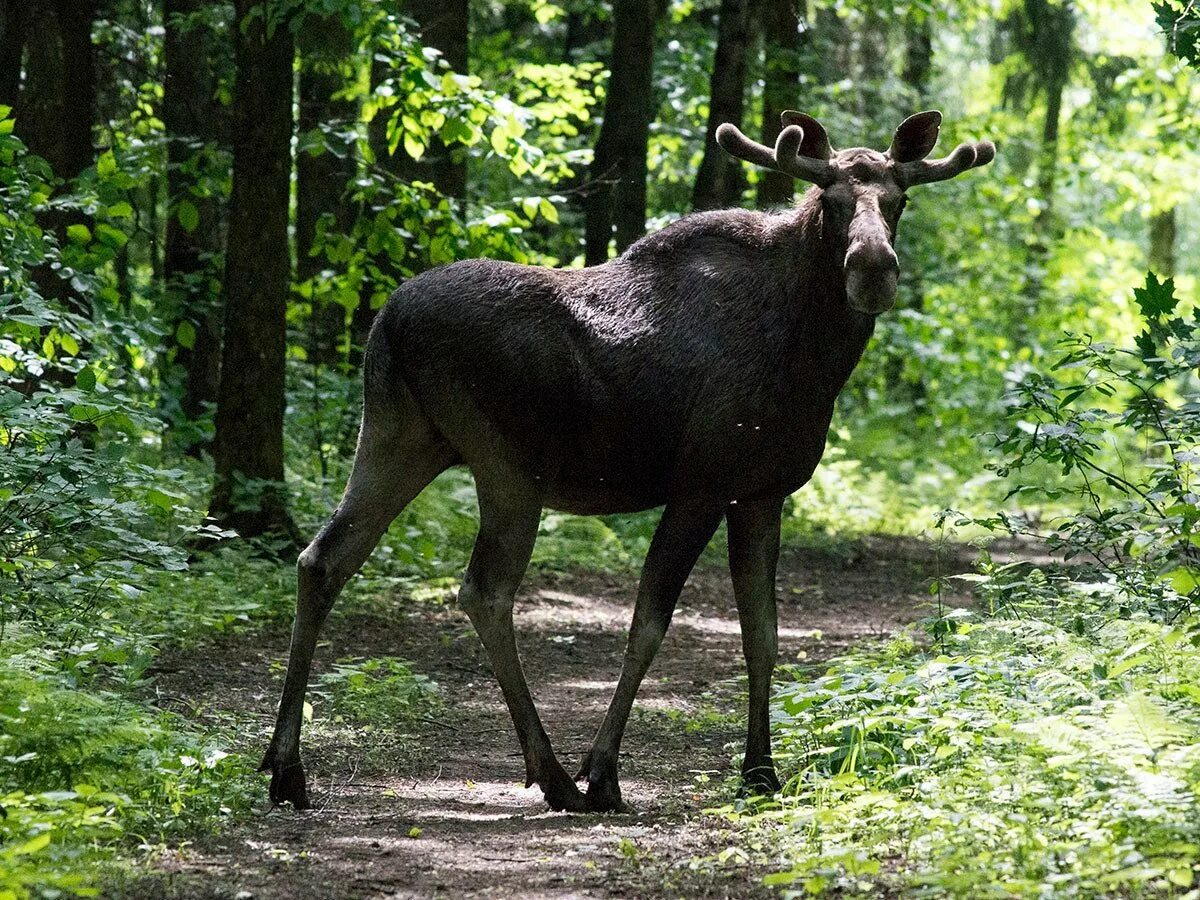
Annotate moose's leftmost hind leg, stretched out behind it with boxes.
[259,408,455,809]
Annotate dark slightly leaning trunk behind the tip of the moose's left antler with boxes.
[691,0,750,210]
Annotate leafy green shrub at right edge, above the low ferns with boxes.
[960,274,1200,620]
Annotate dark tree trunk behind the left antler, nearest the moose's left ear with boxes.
[756,0,814,209]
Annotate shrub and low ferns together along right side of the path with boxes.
[732,282,1200,896]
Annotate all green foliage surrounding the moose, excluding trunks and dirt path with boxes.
[0,0,1200,896]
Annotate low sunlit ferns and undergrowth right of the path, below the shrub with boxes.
[724,592,1200,898]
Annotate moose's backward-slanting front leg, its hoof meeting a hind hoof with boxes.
[577,500,724,812]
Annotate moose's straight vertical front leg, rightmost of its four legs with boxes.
[726,497,784,793]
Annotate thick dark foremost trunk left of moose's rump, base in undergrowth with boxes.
[209,0,294,536]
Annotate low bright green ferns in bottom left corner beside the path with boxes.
[0,644,253,898]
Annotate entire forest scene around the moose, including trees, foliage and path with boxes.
[0,0,1200,900]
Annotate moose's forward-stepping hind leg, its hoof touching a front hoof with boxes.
[458,473,586,812]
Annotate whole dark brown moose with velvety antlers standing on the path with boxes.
[262,110,996,811]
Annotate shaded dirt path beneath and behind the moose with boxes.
[113,538,973,900]
